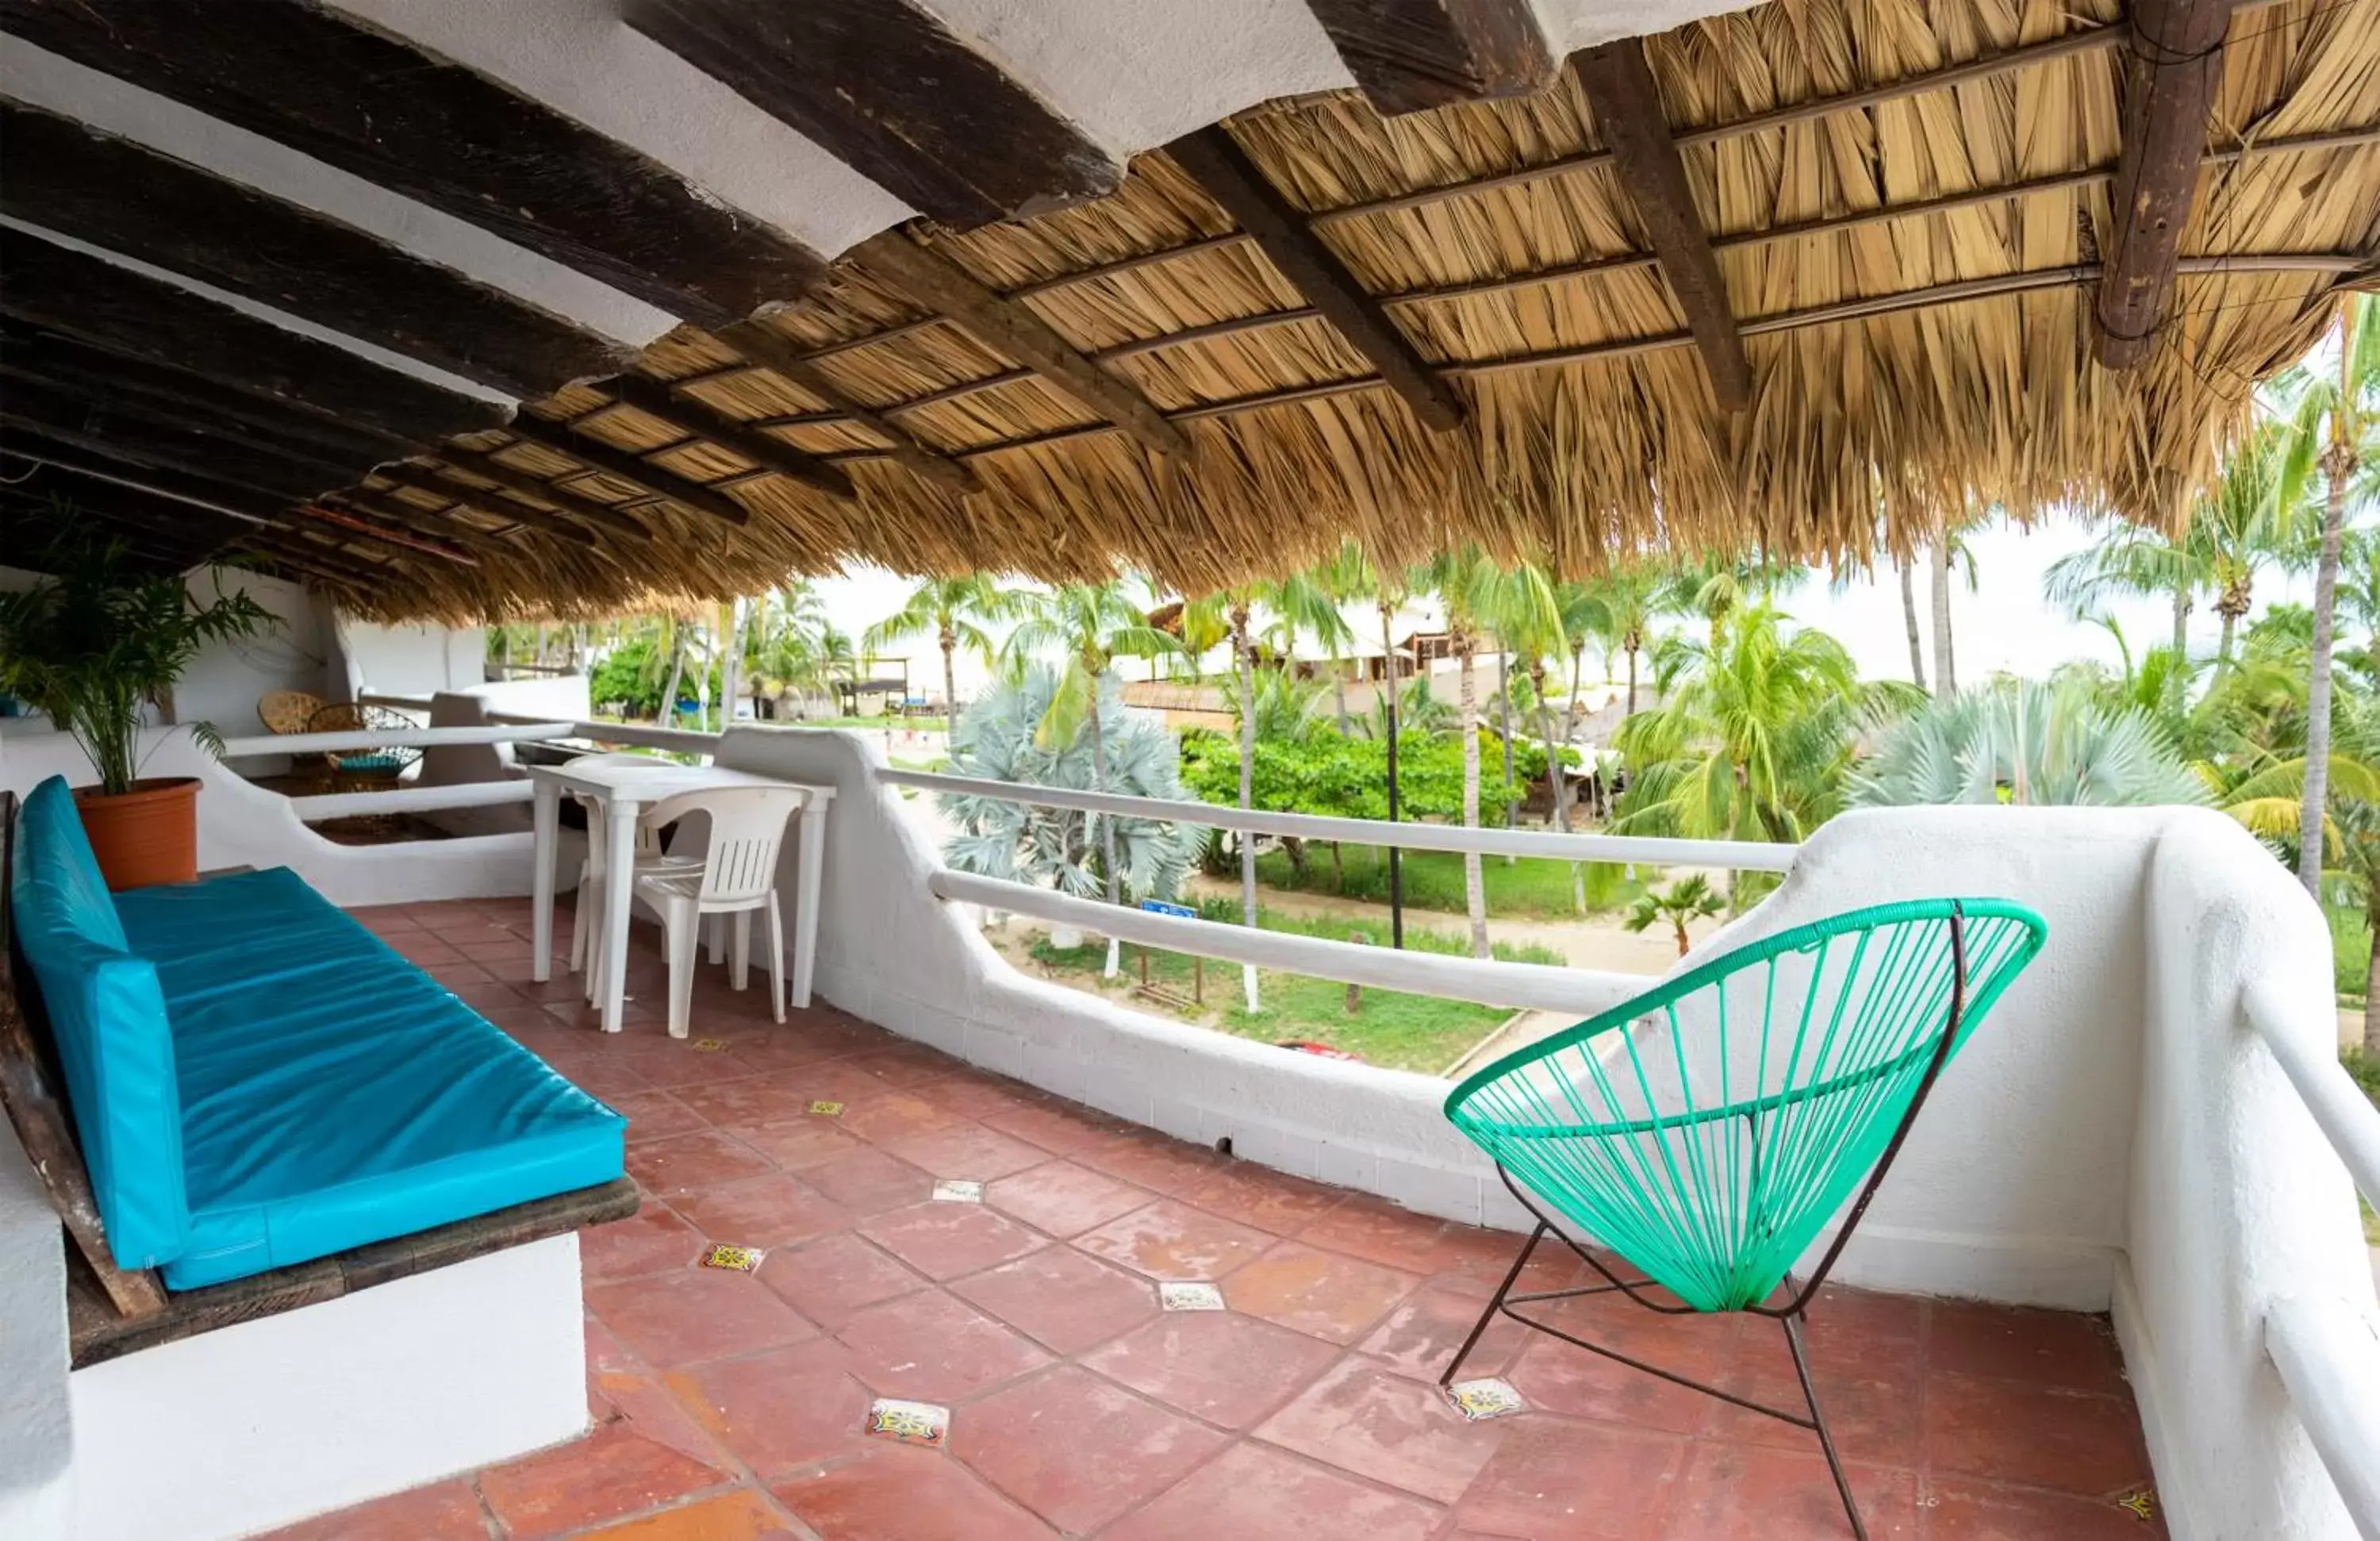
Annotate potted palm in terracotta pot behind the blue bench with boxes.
[0,536,276,889]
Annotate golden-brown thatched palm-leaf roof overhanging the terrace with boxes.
[9,0,2380,617]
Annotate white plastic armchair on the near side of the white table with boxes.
[635,786,804,1039]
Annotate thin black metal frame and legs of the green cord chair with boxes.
[1438,908,1966,1541]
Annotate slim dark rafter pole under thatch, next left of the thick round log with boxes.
[1578,38,1752,412]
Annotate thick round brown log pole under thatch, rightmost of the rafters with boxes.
[2092,0,2232,369]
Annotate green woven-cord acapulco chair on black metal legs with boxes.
[1440,898,2049,1541]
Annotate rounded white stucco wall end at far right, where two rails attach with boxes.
[2116,810,2380,1541]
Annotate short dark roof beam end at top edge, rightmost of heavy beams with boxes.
[1307,0,1559,117]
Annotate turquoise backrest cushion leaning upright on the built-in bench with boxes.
[12,777,190,1267]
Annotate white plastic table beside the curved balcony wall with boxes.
[528,759,835,1034]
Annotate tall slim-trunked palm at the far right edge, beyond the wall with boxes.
[2280,295,2380,898]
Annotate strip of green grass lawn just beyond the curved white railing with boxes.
[1031,901,1561,1074]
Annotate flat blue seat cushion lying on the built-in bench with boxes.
[119,867,626,1289]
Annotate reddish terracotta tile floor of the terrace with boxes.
[270,901,2163,1541]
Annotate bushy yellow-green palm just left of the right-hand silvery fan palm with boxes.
[1614,602,1916,898]
